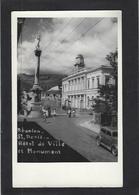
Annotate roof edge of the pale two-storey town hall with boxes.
[62,65,112,81]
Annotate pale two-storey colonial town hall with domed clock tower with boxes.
[62,55,114,109]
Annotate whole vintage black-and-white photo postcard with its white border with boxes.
[11,10,123,187]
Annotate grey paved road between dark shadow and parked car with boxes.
[35,115,117,162]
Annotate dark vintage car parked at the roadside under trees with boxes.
[96,126,118,156]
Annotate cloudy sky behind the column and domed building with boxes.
[17,17,117,74]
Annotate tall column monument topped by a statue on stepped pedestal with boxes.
[29,35,42,118]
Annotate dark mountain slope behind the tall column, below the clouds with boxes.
[18,73,67,91]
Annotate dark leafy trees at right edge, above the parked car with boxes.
[93,51,118,126]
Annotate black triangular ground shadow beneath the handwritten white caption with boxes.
[17,121,88,162]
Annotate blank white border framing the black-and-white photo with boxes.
[11,10,123,188]
